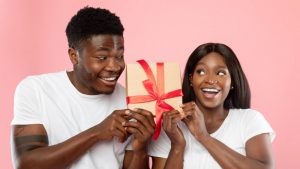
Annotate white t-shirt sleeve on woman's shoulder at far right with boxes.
[243,109,276,143]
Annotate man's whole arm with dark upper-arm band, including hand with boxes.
[13,111,127,169]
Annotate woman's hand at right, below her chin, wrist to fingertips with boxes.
[181,102,209,142]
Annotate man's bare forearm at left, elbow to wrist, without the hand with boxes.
[17,128,98,169]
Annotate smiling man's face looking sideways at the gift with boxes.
[73,35,125,95]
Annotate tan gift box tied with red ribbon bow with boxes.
[126,60,182,139]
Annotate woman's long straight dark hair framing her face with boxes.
[182,43,251,109]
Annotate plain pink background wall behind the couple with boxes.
[0,0,300,169]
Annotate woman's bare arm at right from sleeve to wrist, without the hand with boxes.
[197,134,275,169]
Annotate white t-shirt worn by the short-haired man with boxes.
[11,71,128,169]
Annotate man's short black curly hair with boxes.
[66,7,124,49]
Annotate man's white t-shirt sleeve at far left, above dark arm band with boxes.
[11,77,42,125]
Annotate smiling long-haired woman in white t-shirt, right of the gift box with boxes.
[149,43,275,169]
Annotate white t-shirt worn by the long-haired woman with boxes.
[149,109,275,169]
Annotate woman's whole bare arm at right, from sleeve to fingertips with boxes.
[183,103,274,169]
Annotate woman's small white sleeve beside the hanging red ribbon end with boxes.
[148,125,171,158]
